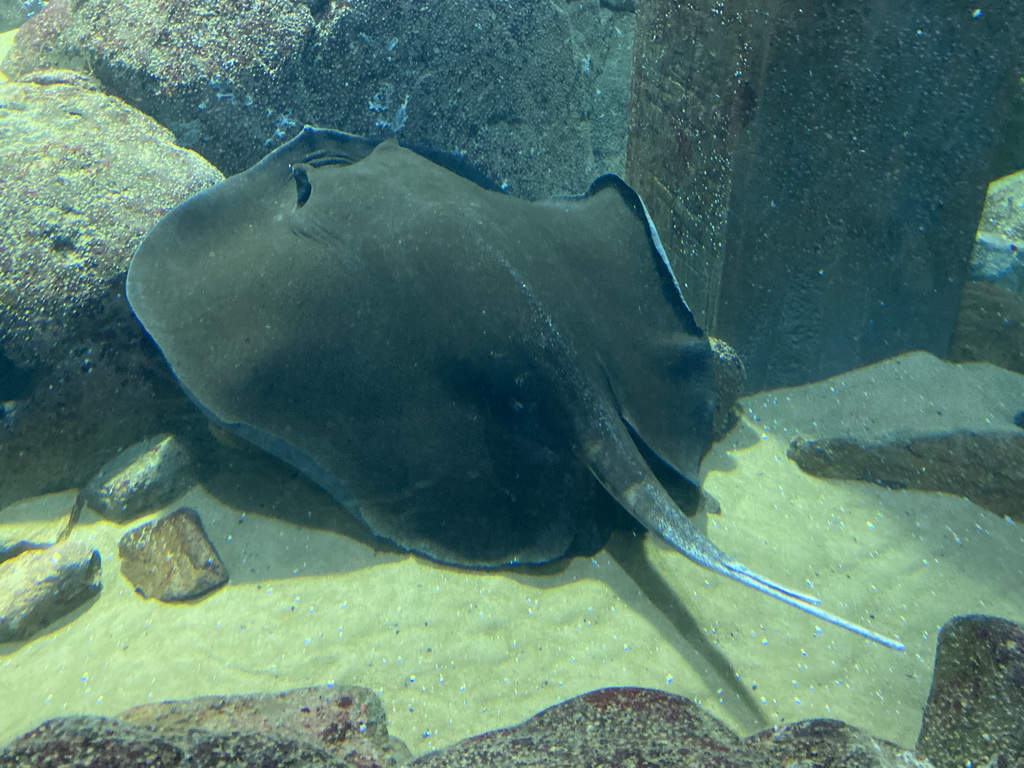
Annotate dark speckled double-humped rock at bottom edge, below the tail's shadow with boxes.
[410,688,926,768]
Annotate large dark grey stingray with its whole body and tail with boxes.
[127,127,902,648]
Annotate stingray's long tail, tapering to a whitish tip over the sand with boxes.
[584,419,905,650]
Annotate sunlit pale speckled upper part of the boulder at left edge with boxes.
[0,71,220,369]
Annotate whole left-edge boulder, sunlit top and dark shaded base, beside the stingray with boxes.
[0,71,221,505]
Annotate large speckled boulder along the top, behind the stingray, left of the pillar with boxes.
[3,0,626,198]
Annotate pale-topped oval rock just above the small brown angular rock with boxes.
[77,434,195,522]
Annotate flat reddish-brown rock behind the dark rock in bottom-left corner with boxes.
[118,686,410,766]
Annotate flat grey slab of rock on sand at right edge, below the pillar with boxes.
[751,352,1024,520]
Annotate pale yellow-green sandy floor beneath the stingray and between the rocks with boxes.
[0,354,1024,754]
